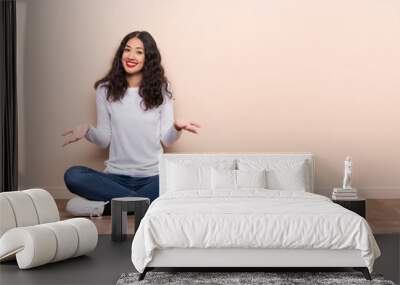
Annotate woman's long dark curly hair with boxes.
[94,31,172,110]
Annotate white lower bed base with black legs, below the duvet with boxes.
[139,248,371,280]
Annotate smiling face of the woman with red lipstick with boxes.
[121,38,145,75]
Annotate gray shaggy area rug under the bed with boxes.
[117,271,395,285]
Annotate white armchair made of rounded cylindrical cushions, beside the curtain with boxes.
[0,189,98,269]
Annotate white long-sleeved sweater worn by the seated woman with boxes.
[85,86,181,177]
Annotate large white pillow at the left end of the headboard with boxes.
[167,163,211,191]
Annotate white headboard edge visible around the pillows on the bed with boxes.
[159,153,314,195]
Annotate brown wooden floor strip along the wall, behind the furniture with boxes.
[56,199,400,234]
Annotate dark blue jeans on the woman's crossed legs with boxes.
[64,166,159,202]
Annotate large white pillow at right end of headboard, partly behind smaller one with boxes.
[238,159,311,191]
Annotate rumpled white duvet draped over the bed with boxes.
[132,189,380,272]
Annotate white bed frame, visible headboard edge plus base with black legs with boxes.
[139,153,371,280]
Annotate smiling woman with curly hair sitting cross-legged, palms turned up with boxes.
[63,31,200,213]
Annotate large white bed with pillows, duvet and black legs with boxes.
[132,153,380,280]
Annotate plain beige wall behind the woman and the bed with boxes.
[17,0,400,198]
